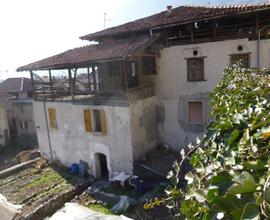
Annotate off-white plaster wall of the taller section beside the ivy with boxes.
[155,39,270,150]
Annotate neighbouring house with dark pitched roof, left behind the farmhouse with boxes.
[0,78,36,143]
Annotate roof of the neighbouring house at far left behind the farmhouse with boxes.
[0,77,32,93]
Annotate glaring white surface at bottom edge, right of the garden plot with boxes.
[45,203,131,220]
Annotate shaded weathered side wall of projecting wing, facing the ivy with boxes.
[129,96,159,160]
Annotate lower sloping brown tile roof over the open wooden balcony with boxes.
[17,36,157,71]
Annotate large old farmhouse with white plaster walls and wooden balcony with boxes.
[18,4,270,177]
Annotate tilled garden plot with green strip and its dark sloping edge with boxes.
[0,160,92,220]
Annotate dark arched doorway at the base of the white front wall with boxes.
[95,153,109,179]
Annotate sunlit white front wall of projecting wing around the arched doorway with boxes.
[34,101,133,175]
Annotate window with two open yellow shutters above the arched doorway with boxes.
[83,109,107,134]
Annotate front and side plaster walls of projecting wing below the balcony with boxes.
[34,97,158,176]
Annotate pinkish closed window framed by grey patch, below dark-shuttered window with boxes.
[188,101,203,124]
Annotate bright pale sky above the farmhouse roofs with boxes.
[0,0,266,79]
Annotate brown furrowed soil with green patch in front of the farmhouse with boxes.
[0,164,92,216]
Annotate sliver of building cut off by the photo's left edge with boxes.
[0,93,14,147]
